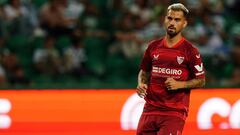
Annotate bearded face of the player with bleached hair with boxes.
[164,10,187,37]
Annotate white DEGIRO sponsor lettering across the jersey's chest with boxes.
[152,66,182,75]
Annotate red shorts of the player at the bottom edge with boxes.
[137,114,185,135]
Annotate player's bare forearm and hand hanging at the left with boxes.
[136,70,150,98]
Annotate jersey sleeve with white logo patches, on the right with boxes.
[189,48,205,79]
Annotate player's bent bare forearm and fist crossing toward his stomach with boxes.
[165,78,205,90]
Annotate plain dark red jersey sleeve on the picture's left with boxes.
[140,45,152,72]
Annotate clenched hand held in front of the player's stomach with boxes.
[165,78,184,90]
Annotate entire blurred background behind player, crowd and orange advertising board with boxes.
[0,0,240,135]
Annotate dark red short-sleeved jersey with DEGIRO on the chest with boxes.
[140,38,205,119]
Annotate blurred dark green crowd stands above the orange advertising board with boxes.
[0,0,240,89]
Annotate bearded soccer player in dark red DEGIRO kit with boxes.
[136,3,205,135]
